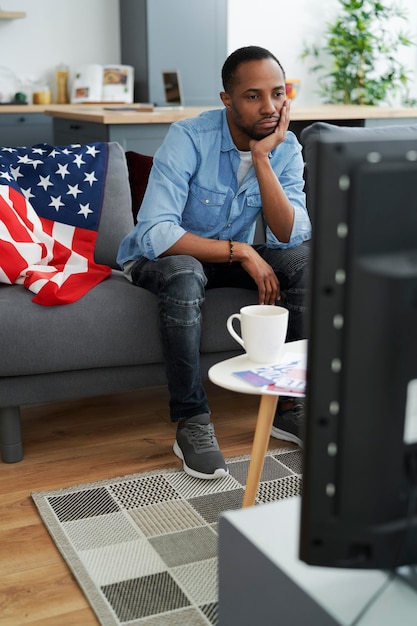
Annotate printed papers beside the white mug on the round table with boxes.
[233,352,307,397]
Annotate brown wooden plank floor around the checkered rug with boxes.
[0,383,288,626]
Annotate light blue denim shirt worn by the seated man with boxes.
[117,109,311,267]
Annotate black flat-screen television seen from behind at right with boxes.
[299,127,417,569]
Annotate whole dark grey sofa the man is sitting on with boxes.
[0,143,257,463]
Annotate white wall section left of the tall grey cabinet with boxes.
[0,0,120,100]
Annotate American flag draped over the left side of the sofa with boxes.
[0,143,111,305]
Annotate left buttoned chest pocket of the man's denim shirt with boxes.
[182,183,228,232]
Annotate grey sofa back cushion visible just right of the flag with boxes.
[94,141,134,269]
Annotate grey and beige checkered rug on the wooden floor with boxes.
[32,448,302,626]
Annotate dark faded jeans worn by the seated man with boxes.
[132,243,309,422]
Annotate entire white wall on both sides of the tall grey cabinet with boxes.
[0,0,417,106]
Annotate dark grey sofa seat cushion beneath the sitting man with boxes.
[0,271,258,376]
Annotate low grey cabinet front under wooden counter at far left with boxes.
[0,111,53,147]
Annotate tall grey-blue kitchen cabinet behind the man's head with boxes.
[120,0,227,106]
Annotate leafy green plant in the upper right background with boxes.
[301,0,416,106]
